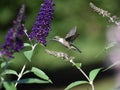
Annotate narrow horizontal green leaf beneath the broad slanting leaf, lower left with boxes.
[15,78,50,84]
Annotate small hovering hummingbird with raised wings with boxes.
[52,26,81,53]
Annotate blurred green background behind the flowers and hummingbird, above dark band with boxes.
[0,0,120,90]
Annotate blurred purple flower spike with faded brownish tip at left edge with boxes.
[0,5,25,58]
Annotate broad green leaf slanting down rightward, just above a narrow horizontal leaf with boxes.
[31,67,52,83]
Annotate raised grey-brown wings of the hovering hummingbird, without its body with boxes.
[65,26,79,42]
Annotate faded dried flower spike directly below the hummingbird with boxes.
[45,49,75,61]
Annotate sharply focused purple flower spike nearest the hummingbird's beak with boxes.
[29,0,54,46]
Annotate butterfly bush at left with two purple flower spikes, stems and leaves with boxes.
[0,0,54,90]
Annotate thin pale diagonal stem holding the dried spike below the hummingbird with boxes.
[70,60,95,90]
